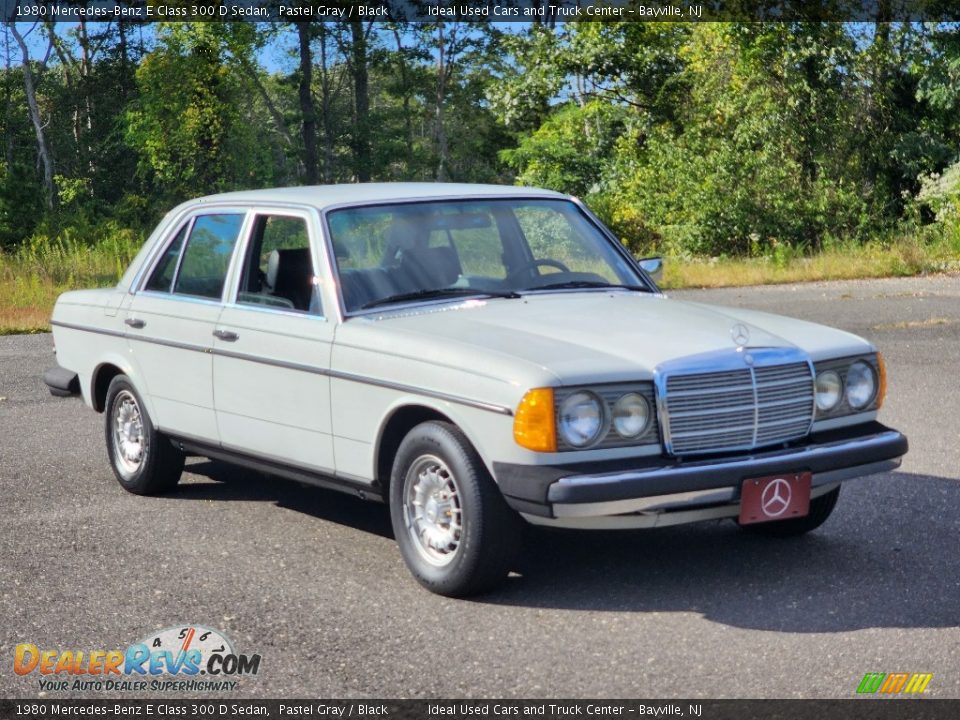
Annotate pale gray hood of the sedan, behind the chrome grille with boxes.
[346,291,872,383]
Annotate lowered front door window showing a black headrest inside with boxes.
[237,215,322,315]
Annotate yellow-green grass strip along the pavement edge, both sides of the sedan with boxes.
[0,227,960,335]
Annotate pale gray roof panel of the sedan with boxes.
[185,183,566,210]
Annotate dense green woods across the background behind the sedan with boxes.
[0,22,960,256]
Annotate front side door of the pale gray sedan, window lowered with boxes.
[213,208,335,474]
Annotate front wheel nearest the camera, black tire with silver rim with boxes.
[390,421,522,597]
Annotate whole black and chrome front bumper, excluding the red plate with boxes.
[494,422,908,526]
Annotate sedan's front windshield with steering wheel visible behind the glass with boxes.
[328,199,649,312]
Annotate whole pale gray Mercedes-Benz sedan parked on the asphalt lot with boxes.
[45,184,907,595]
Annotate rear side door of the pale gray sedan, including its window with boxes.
[124,209,246,443]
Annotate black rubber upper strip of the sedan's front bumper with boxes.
[494,422,908,516]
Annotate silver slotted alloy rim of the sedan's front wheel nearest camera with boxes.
[403,455,463,566]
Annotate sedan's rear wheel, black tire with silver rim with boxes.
[104,375,184,495]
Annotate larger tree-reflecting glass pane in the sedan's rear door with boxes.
[173,213,244,299]
